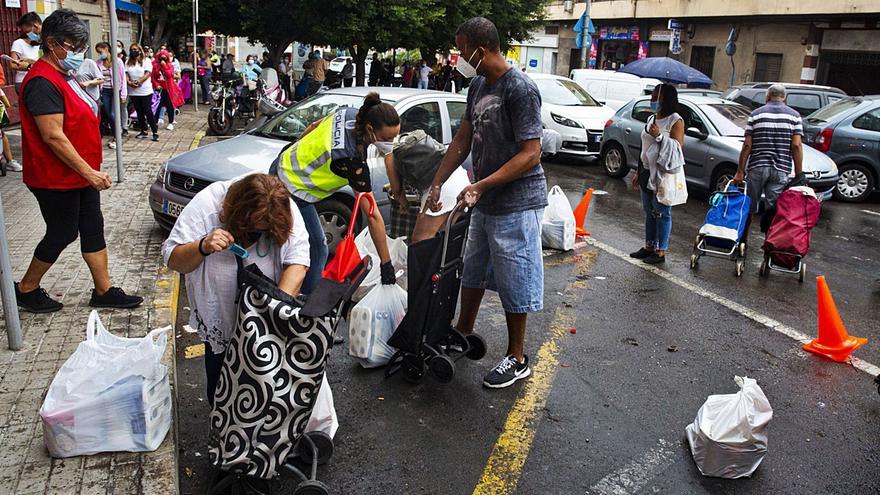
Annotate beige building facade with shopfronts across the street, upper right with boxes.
[517,0,880,94]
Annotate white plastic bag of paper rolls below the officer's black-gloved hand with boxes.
[348,284,406,368]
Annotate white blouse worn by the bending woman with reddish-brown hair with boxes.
[162,178,309,354]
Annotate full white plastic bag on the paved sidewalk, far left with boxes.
[40,311,172,457]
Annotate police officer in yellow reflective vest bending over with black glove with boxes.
[270,93,400,294]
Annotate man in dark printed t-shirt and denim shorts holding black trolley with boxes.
[428,17,547,388]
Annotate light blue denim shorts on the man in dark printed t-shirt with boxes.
[461,208,544,313]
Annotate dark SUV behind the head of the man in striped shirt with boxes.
[721,83,846,117]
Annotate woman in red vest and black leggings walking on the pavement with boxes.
[15,9,143,313]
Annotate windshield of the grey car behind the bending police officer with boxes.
[255,93,374,141]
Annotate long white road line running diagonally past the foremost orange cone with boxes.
[587,237,880,376]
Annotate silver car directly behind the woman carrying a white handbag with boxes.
[601,94,837,200]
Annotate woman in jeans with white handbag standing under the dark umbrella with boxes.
[630,84,687,265]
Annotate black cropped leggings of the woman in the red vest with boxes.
[28,186,107,263]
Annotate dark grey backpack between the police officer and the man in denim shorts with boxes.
[393,130,446,191]
